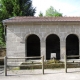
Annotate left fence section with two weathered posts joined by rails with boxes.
[4,56,44,76]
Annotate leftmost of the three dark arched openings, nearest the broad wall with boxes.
[26,34,40,57]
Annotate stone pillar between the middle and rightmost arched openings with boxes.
[60,39,66,59]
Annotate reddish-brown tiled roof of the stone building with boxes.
[3,16,80,23]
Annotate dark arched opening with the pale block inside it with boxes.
[46,34,60,60]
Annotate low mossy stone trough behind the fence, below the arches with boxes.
[20,60,80,69]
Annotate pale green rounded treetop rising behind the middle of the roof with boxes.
[45,6,62,17]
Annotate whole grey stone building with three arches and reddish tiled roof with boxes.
[3,17,80,60]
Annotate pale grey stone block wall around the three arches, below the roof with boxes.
[6,23,80,59]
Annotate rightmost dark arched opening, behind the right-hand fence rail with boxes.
[66,34,79,59]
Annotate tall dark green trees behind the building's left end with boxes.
[0,0,36,46]
